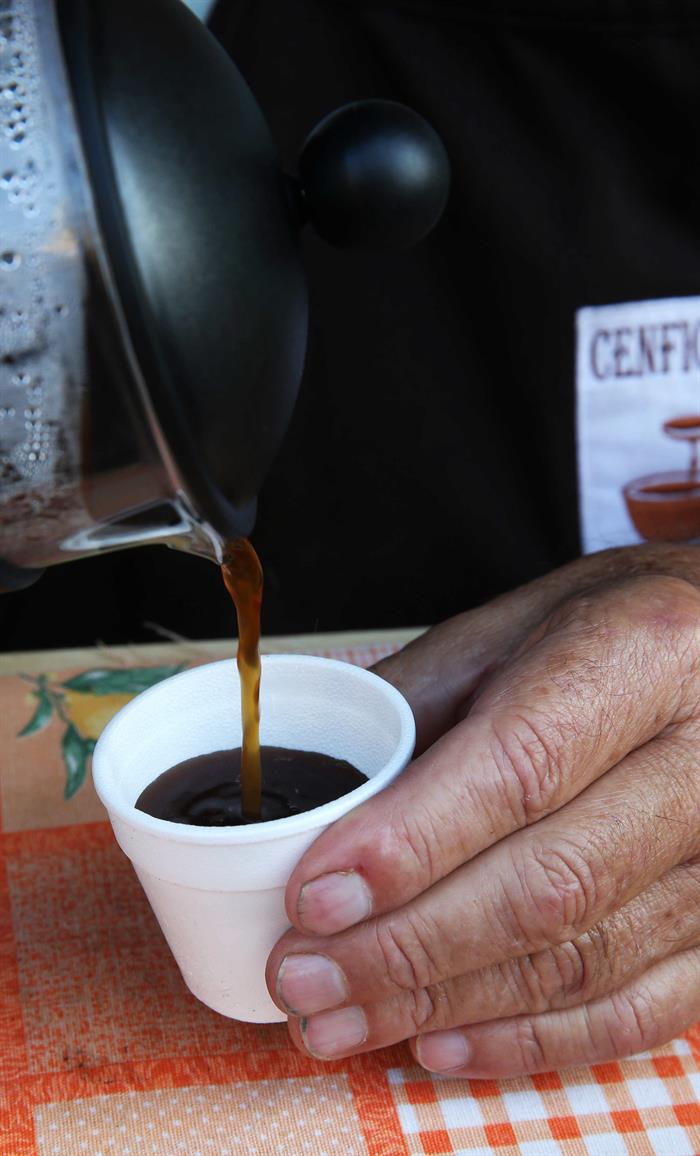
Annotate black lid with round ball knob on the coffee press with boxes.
[57,0,449,536]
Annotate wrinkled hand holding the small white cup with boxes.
[268,547,700,1077]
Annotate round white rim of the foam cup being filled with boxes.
[92,654,416,846]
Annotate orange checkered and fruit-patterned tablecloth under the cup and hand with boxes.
[0,637,700,1156]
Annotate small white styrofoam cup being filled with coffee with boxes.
[92,654,416,1023]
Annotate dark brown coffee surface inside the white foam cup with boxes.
[136,747,367,827]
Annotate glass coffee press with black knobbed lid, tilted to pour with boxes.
[0,0,449,588]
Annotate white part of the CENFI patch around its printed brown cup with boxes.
[576,297,700,551]
